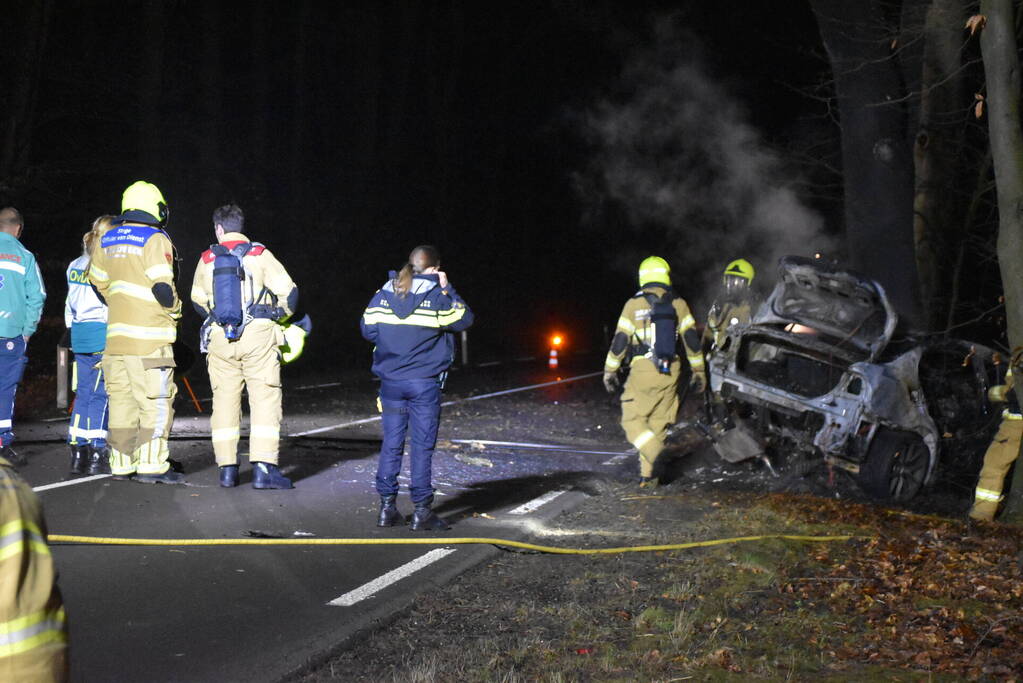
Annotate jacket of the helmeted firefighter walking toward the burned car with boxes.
[604,284,704,372]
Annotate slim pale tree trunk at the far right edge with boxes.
[980,0,1023,521]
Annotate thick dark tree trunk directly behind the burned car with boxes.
[811,0,921,323]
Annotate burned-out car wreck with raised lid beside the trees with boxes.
[707,257,997,501]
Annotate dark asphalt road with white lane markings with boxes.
[17,360,631,681]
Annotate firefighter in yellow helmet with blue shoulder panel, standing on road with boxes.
[89,180,184,484]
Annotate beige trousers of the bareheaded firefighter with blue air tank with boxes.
[206,319,283,467]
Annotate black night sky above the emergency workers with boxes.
[0,0,840,366]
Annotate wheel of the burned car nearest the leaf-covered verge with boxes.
[858,428,930,503]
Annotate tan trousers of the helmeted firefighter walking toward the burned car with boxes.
[622,358,682,476]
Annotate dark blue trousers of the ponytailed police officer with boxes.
[376,377,441,504]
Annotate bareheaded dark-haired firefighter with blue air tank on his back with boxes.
[191,204,299,489]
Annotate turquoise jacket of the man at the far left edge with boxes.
[0,232,46,338]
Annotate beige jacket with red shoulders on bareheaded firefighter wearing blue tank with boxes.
[191,232,298,331]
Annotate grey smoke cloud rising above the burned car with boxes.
[576,18,832,308]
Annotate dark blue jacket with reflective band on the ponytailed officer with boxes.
[359,272,473,379]
